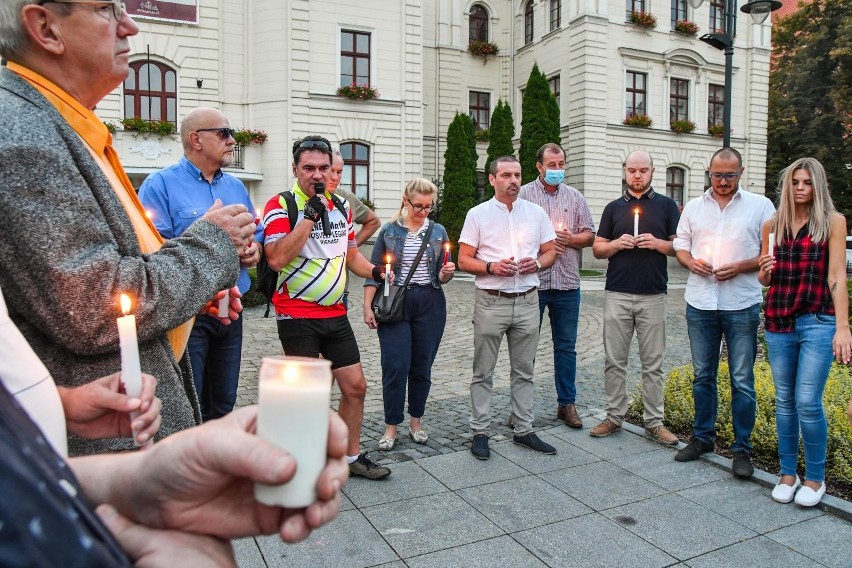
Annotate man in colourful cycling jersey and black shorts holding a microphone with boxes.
[263,136,391,479]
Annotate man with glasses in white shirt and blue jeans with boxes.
[674,148,775,477]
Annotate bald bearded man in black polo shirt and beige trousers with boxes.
[590,150,680,445]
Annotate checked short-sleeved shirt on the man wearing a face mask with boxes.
[519,177,595,290]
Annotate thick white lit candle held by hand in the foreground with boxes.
[254,357,331,507]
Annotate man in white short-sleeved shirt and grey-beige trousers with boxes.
[459,156,556,460]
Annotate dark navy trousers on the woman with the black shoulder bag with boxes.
[377,284,447,425]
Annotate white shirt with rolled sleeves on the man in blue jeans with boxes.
[674,188,775,310]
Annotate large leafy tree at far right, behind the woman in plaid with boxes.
[766,0,852,218]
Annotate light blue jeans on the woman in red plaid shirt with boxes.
[766,314,835,482]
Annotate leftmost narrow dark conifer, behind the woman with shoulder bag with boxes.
[441,113,477,242]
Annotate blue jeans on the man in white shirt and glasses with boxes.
[686,304,760,454]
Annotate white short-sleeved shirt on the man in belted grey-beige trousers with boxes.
[459,198,556,292]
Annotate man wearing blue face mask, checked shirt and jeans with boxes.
[520,144,595,428]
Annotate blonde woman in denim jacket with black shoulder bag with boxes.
[364,179,456,451]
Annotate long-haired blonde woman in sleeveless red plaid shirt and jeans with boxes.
[758,158,852,507]
